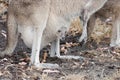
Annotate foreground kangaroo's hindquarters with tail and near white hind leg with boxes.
[0,0,58,68]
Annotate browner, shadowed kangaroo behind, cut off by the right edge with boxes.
[88,0,120,47]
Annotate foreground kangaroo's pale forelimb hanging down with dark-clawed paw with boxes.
[79,0,108,43]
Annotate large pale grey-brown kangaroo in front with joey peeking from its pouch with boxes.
[0,0,108,68]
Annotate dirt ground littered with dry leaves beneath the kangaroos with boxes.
[0,15,120,80]
